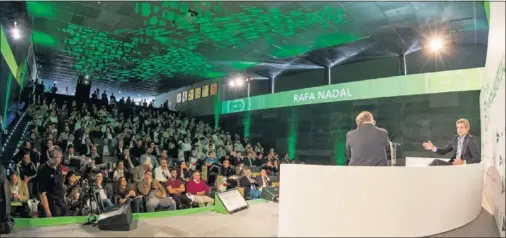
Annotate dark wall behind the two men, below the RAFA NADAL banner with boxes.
[215,91,480,164]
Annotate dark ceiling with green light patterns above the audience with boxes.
[14,1,488,95]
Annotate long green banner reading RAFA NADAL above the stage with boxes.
[221,68,483,114]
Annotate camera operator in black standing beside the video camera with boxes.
[37,146,67,217]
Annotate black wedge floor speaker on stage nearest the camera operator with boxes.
[97,202,133,231]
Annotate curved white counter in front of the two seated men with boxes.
[278,164,483,237]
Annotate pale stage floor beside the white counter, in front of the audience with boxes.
[2,202,499,237]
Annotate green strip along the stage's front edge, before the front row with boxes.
[15,199,267,228]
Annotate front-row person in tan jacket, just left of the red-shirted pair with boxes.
[137,170,176,212]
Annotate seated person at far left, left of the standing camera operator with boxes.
[9,172,31,218]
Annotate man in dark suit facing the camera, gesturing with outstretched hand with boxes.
[422,118,481,166]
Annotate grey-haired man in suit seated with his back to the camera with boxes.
[346,111,388,166]
